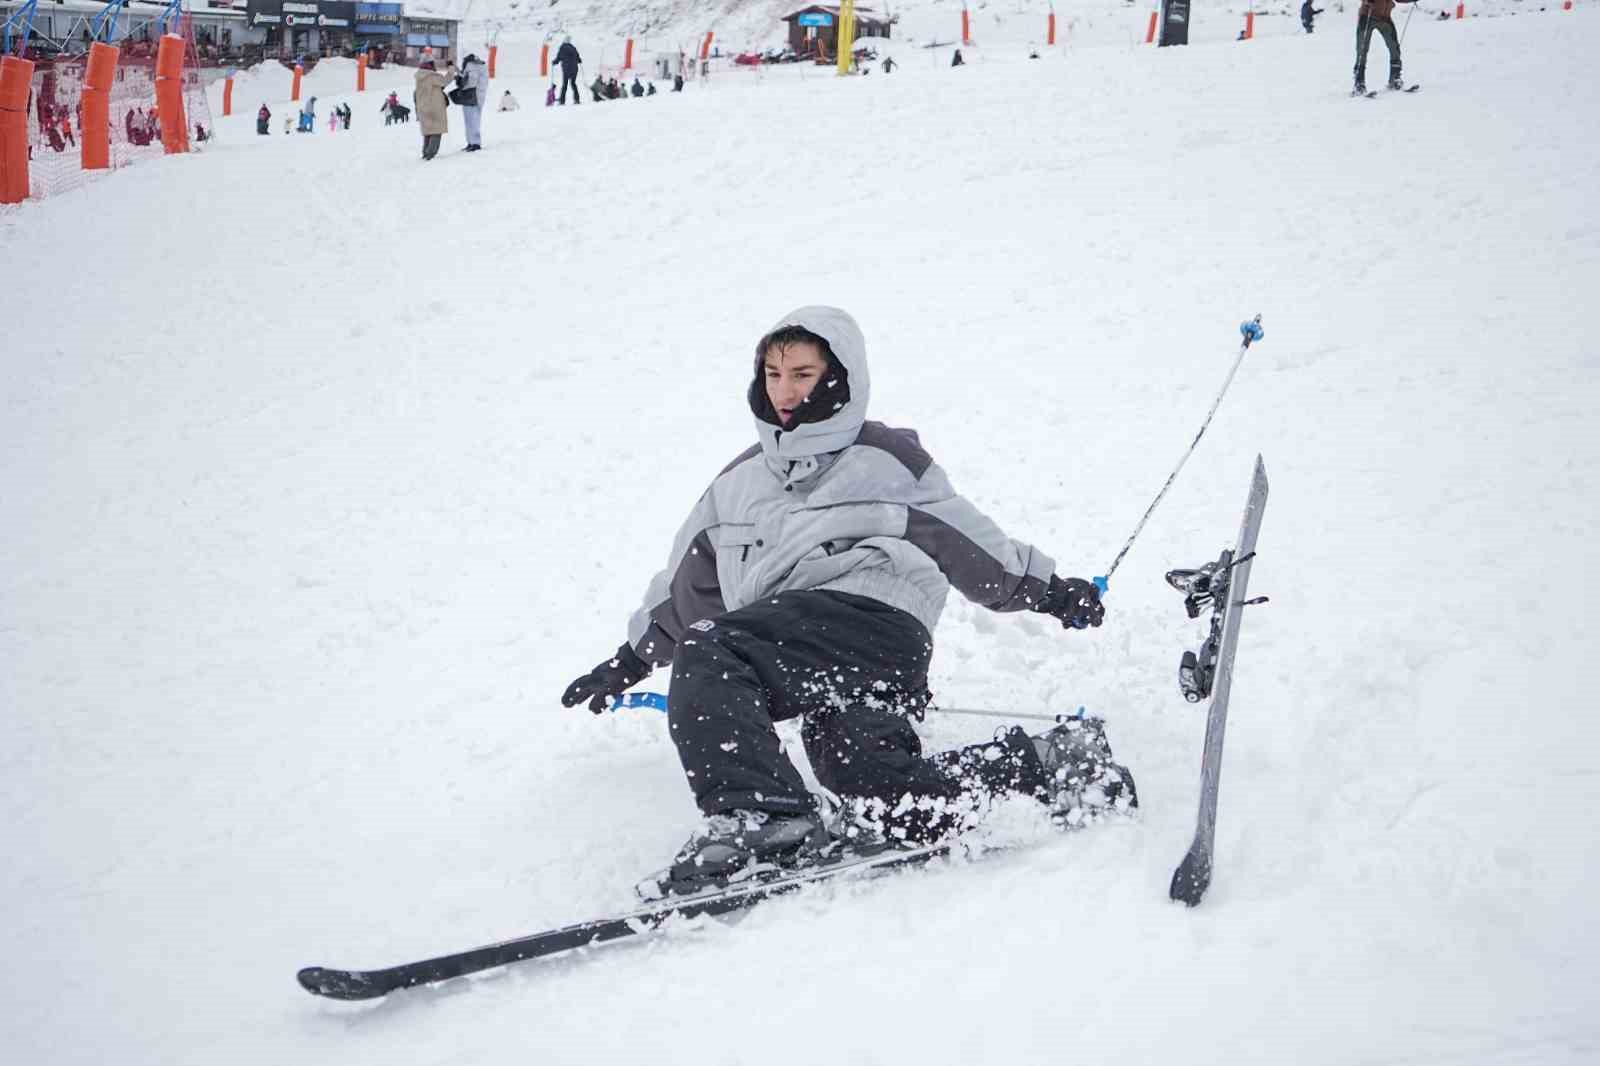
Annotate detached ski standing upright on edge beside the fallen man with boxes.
[1166,456,1267,906]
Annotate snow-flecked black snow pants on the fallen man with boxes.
[669,591,1046,840]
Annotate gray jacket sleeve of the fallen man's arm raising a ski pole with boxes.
[906,463,1056,611]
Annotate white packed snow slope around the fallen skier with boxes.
[0,8,1600,1066]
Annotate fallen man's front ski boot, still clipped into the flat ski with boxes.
[637,810,834,900]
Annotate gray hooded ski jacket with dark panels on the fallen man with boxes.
[627,300,1054,666]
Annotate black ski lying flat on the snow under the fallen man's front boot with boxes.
[296,844,955,999]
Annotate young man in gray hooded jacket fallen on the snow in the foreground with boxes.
[562,307,1138,895]
